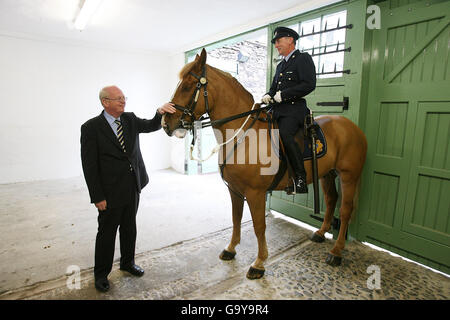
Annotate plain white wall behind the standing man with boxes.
[0,36,176,183]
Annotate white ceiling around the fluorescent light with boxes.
[0,0,336,53]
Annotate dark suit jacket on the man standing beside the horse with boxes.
[81,111,161,208]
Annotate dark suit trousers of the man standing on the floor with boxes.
[94,172,139,279]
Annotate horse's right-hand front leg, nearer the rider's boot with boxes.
[247,191,269,279]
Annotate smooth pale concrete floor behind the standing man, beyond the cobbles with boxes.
[0,170,251,293]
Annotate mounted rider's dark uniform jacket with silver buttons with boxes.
[267,50,316,117]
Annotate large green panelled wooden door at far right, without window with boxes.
[357,1,450,273]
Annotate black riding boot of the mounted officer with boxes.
[284,142,308,195]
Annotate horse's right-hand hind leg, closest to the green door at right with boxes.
[326,171,359,266]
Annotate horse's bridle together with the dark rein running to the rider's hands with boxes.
[174,65,272,130]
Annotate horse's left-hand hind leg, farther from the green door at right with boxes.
[311,171,338,242]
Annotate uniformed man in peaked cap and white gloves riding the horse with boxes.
[261,27,316,194]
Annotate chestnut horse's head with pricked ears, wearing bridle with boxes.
[162,49,209,138]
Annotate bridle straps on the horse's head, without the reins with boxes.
[174,65,209,130]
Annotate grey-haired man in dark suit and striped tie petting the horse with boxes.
[81,86,176,292]
